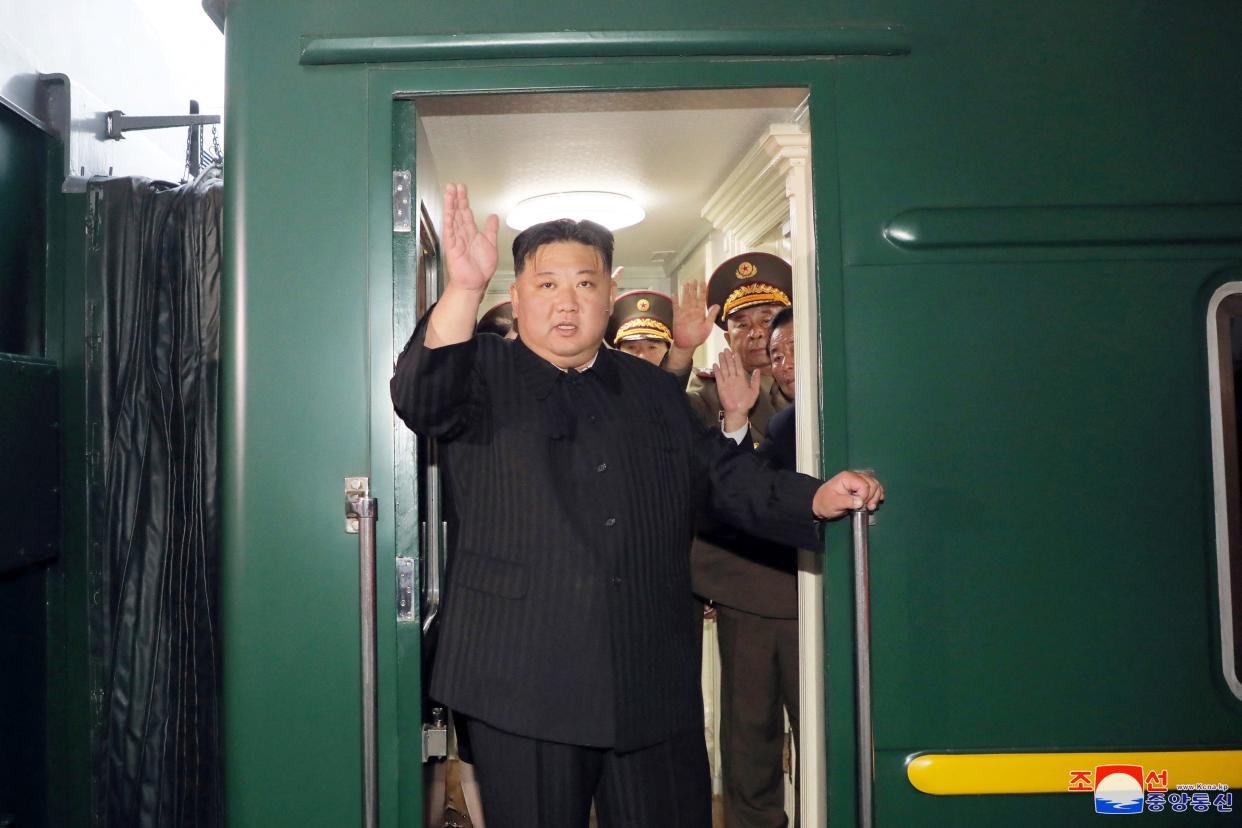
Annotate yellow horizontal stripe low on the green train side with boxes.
[905,750,1242,796]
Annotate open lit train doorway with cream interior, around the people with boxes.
[392,87,830,826]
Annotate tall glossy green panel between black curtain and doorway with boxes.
[221,22,372,826]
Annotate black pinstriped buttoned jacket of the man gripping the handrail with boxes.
[391,318,818,750]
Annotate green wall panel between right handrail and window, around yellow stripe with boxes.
[846,262,1242,826]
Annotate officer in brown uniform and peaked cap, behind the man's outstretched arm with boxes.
[666,252,799,828]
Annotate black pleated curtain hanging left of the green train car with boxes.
[87,171,224,828]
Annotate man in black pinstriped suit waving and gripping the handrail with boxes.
[391,185,883,828]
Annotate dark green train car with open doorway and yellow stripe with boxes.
[7,0,1242,828]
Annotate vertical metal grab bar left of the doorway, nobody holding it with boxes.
[345,477,379,828]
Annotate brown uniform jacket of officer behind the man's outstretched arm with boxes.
[686,374,799,618]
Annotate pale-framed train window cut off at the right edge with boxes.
[1207,282,1242,698]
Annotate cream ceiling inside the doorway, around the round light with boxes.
[417,89,806,276]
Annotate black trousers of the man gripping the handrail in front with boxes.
[468,719,712,828]
